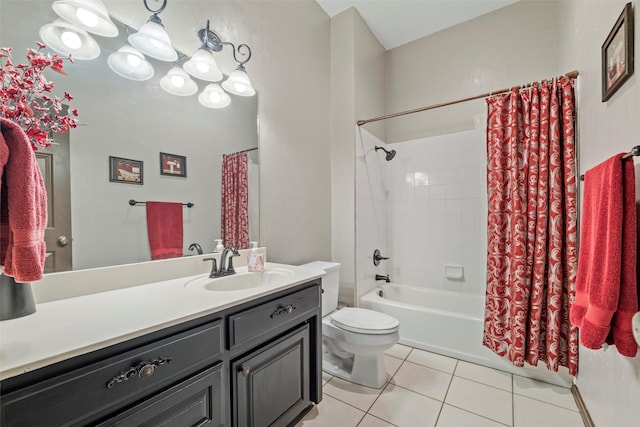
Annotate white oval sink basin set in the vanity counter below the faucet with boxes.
[184,267,294,292]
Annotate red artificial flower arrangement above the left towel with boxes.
[0,42,78,151]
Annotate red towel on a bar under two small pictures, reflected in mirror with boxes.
[147,202,182,259]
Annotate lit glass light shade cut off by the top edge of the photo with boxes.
[51,0,118,37]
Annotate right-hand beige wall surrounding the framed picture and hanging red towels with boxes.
[558,0,640,427]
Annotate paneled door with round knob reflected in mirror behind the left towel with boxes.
[36,129,72,273]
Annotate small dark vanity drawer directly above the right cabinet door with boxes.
[228,286,320,350]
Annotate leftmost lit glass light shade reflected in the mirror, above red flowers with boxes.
[39,19,100,61]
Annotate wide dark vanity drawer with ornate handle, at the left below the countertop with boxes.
[0,319,224,427]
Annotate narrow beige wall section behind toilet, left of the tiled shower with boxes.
[331,8,385,305]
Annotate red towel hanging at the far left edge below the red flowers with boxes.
[0,118,47,283]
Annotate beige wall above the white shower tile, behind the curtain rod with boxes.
[386,1,569,143]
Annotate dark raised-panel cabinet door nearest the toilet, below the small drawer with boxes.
[232,325,310,427]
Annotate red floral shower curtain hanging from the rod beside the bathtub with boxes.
[483,77,578,375]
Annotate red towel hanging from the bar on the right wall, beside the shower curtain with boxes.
[570,153,638,357]
